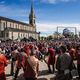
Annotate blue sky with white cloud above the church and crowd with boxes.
[0,0,80,36]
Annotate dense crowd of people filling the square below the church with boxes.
[0,41,80,80]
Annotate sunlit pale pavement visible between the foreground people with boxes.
[6,62,55,80]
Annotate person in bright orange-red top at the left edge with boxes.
[0,48,8,80]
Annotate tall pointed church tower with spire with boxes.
[29,5,36,27]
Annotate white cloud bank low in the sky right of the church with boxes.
[37,23,80,36]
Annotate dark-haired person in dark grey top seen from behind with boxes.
[56,45,72,80]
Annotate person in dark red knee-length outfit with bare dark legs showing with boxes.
[48,48,55,73]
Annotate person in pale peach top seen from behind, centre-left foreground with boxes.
[24,49,39,80]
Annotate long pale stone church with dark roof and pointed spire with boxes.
[0,5,39,40]
